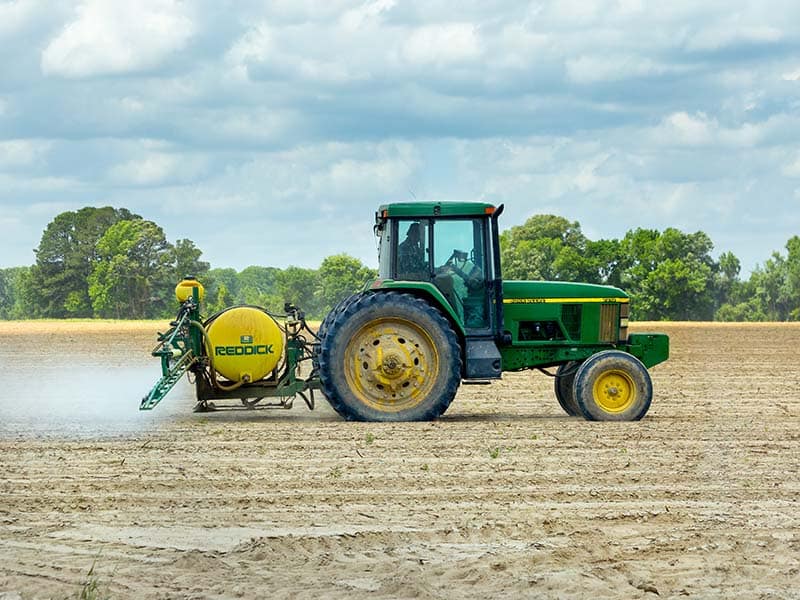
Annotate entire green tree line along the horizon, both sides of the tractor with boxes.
[0,207,800,321]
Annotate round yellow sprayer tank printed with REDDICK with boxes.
[207,306,283,381]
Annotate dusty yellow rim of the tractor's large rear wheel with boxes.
[344,317,439,412]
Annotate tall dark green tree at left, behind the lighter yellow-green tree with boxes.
[30,206,141,318]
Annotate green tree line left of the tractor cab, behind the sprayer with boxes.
[0,207,376,319]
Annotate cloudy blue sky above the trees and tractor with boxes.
[0,0,800,275]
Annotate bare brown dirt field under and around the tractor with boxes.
[0,323,800,600]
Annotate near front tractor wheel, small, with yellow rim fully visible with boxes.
[574,350,653,421]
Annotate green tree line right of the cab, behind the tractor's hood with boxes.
[500,215,800,321]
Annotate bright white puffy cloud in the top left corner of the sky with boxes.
[41,0,195,78]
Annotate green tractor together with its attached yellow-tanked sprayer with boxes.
[140,202,669,421]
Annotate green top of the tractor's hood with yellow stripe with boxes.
[503,281,628,304]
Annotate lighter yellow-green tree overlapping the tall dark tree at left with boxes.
[89,220,175,319]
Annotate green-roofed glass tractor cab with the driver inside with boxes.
[375,202,501,336]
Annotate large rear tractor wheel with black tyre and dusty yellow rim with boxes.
[319,292,461,421]
